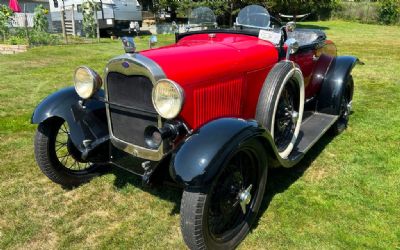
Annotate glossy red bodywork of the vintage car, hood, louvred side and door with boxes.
[141,33,336,129]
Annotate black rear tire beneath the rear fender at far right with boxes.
[330,75,354,136]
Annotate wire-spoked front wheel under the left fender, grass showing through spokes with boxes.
[35,119,99,188]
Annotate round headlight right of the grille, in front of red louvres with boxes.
[152,79,184,119]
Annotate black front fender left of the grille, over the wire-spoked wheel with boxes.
[31,87,108,152]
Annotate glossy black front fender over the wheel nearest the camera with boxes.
[170,118,271,187]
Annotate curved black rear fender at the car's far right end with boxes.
[317,56,359,115]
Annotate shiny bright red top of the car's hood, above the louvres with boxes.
[141,33,278,86]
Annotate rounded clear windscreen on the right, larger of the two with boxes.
[236,5,270,29]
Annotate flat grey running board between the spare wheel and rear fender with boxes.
[288,112,338,160]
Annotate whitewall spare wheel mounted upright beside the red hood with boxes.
[256,61,304,158]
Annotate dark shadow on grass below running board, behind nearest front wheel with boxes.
[252,133,335,230]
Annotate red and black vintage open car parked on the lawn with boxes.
[32,5,358,249]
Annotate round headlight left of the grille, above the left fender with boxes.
[74,66,103,99]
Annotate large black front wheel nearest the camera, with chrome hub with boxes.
[180,139,268,249]
